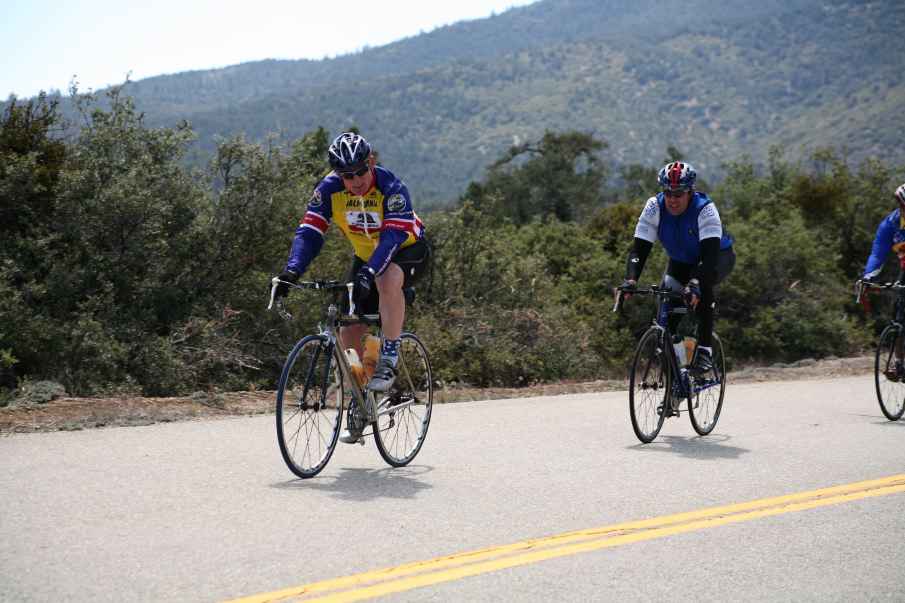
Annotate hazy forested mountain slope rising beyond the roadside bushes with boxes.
[15,0,905,207]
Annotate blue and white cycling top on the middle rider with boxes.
[635,193,732,265]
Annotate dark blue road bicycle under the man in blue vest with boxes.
[613,285,726,444]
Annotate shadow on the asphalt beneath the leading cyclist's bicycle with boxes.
[271,465,434,502]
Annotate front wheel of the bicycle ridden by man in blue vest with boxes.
[628,328,670,444]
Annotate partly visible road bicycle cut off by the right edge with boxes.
[855,280,905,421]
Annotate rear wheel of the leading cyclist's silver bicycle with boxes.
[374,333,434,467]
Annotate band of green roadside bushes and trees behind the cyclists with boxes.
[0,90,905,405]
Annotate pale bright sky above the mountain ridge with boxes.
[0,0,534,100]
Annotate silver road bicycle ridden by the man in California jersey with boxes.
[268,281,434,478]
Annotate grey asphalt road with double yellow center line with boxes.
[0,377,905,602]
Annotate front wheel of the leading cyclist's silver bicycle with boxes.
[276,335,344,478]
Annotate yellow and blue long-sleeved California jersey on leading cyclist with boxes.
[286,167,424,274]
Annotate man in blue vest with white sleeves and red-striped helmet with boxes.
[625,161,735,374]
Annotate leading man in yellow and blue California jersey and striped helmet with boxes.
[276,132,430,404]
